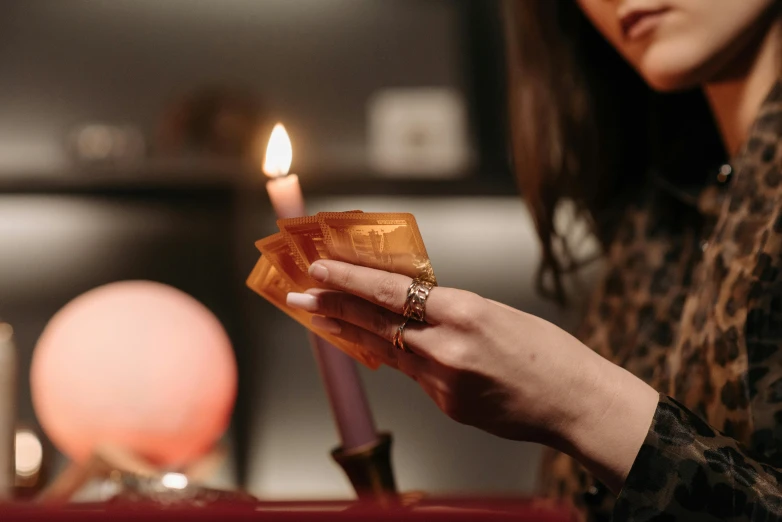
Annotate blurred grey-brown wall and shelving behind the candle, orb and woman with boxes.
[0,0,596,499]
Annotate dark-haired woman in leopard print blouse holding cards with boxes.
[289,0,782,520]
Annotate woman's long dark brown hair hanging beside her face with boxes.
[504,0,724,303]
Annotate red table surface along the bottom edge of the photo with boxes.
[0,499,577,522]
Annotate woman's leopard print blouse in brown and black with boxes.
[542,82,782,521]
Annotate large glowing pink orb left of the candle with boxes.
[30,281,236,466]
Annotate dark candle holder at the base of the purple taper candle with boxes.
[331,433,399,508]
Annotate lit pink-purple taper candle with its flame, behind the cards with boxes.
[263,123,377,451]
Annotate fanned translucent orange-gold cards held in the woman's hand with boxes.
[247,211,437,369]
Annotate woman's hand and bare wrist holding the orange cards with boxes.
[288,261,658,491]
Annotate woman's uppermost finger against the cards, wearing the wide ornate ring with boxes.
[309,260,448,324]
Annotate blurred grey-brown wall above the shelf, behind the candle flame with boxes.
[0,0,465,173]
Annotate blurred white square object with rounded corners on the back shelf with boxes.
[367,88,472,178]
